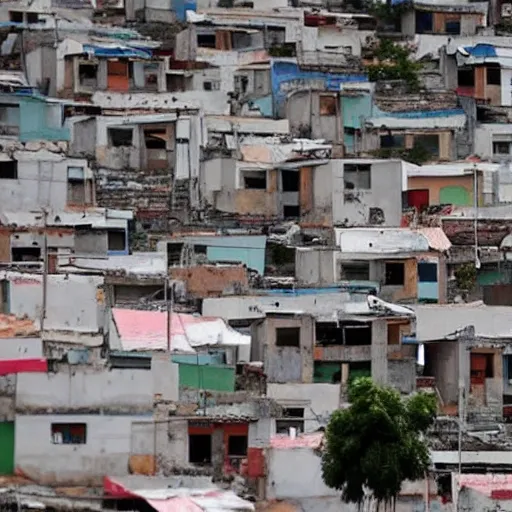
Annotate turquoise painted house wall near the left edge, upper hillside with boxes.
[20,97,70,142]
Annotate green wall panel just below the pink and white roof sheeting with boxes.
[179,363,235,391]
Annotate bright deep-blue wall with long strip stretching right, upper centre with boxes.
[270,59,368,117]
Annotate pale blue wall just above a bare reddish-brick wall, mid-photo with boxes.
[183,236,267,274]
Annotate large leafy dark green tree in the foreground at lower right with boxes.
[322,377,437,506]
